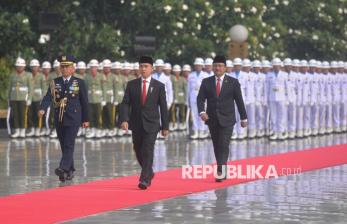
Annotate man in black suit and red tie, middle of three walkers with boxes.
[120,56,169,190]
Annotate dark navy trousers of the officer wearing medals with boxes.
[56,125,79,172]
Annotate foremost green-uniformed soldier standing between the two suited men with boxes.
[170,65,187,130]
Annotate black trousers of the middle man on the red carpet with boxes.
[132,128,158,182]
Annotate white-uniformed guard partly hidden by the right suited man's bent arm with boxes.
[187,58,208,139]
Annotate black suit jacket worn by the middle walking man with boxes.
[119,78,169,133]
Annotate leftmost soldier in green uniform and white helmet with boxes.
[8,58,32,138]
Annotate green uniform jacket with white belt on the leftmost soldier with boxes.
[8,72,32,101]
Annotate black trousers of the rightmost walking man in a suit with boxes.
[208,124,233,172]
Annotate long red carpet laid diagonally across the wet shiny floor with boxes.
[0,145,347,224]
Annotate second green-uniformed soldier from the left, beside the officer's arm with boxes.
[26,59,45,137]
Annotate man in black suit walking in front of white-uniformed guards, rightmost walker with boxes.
[197,56,247,182]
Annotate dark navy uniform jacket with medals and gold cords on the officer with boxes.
[40,76,88,127]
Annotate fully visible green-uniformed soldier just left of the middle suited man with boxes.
[111,61,125,136]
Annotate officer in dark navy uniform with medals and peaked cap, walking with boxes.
[39,55,89,182]
